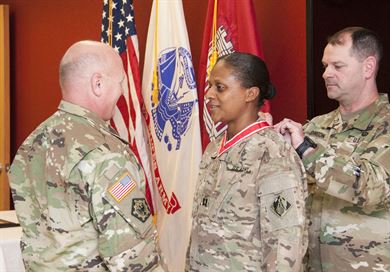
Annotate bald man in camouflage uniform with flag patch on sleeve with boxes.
[10,41,165,272]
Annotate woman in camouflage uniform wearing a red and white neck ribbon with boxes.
[187,53,307,271]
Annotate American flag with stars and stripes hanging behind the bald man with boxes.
[101,0,154,214]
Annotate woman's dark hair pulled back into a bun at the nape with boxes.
[217,52,276,107]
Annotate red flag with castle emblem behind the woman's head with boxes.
[198,0,270,150]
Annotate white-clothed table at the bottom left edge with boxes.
[0,211,25,272]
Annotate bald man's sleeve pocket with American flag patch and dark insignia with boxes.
[103,164,153,238]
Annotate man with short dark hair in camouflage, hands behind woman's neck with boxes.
[275,27,390,272]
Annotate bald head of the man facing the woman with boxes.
[59,41,125,120]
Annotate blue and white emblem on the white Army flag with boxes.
[151,47,198,151]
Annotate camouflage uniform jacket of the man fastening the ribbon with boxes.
[304,95,390,271]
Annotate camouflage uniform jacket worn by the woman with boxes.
[187,128,307,271]
